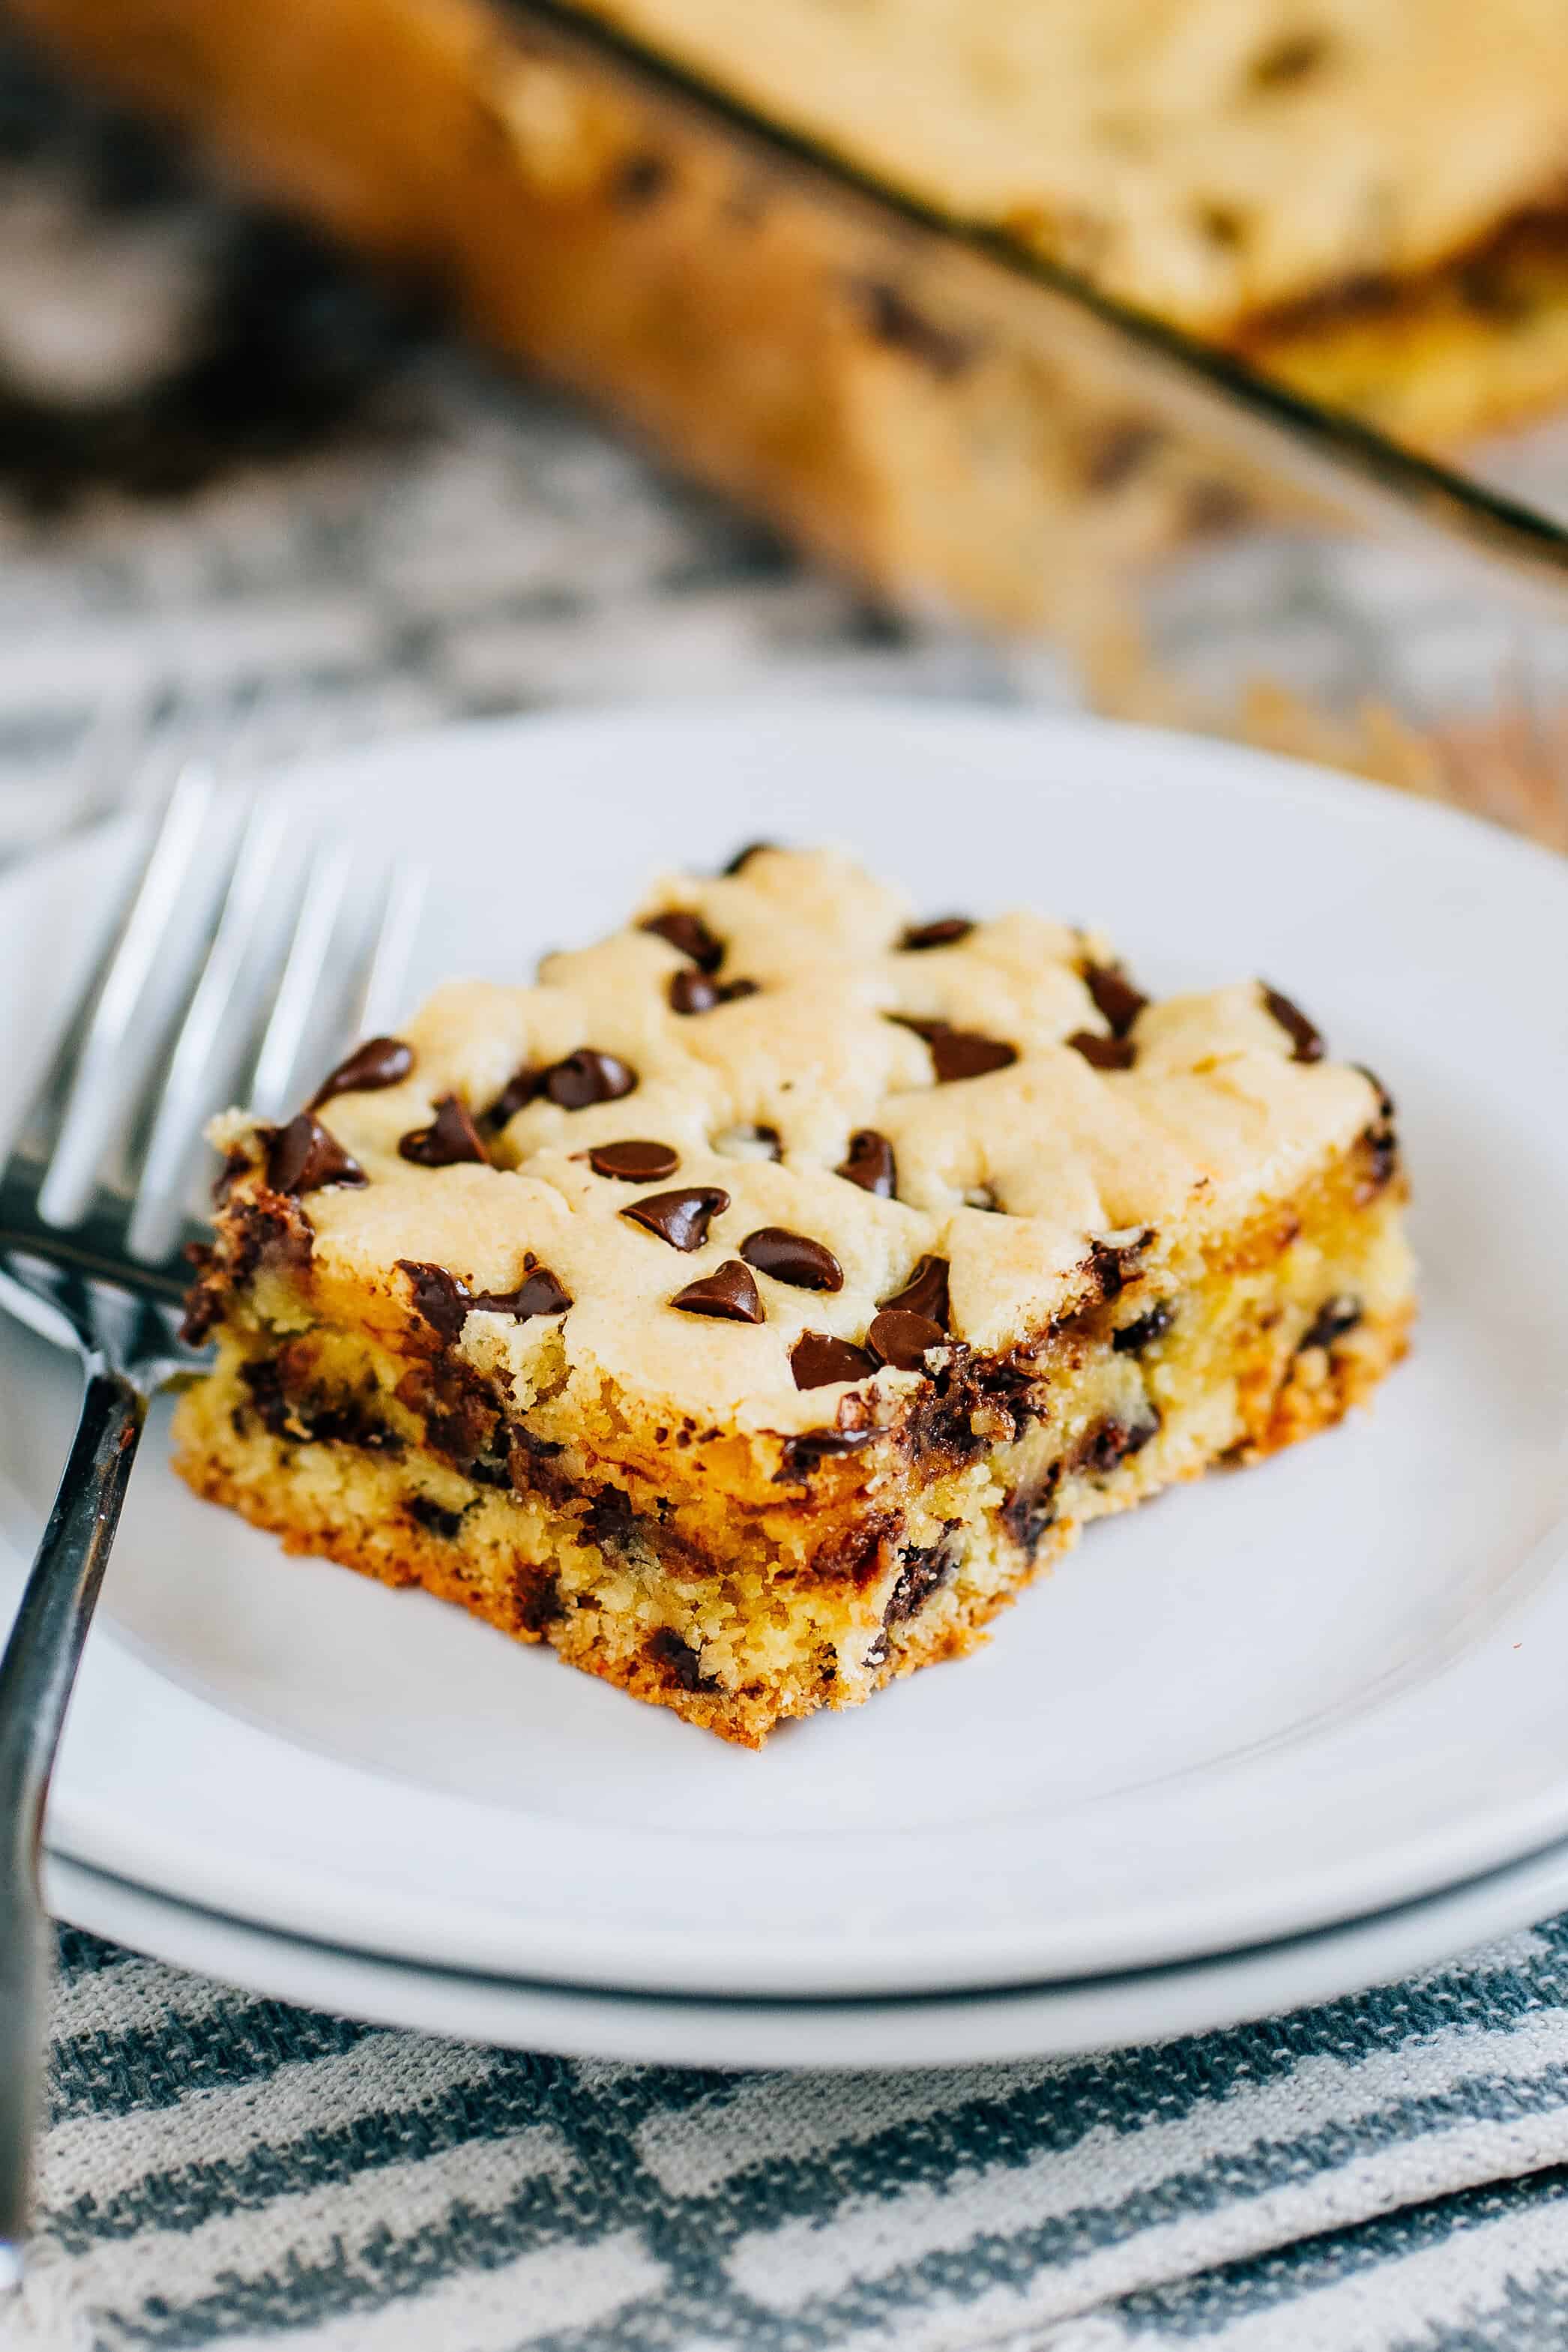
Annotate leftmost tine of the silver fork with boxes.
[37,762,219,1225]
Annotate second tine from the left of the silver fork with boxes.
[127,800,296,1263]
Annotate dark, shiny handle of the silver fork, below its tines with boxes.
[0,1354,148,2288]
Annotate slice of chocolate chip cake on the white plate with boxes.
[176,849,1413,1745]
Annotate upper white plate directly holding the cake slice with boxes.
[0,705,1568,1997]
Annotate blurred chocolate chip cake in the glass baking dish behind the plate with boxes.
[19,0,1568,625]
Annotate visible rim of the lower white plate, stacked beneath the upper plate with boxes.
[47,1844,1568,2067]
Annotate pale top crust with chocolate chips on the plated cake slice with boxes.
[219,849,1380,1432]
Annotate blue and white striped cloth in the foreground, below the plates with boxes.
[18,1920,1568,2352]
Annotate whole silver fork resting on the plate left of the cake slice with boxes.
[0,762,423,2294]
